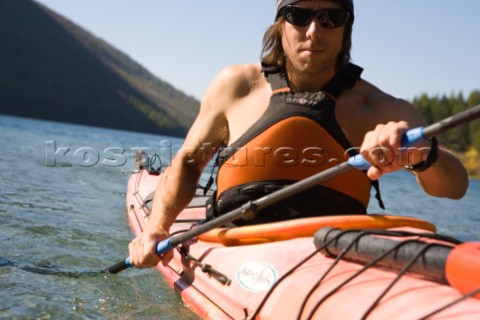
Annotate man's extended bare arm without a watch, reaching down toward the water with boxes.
[129,67,235,267]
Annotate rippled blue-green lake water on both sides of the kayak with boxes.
[0,116,480,319]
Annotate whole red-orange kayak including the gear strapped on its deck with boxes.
[126,169,480,320]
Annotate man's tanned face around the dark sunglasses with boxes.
[282,0,345,75]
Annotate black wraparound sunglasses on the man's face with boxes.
[280,6,350,29]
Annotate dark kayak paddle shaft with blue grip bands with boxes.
[103,105,480,273]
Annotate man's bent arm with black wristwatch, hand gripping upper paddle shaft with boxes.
[360,95,468,199]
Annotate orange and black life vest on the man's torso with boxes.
[214,64,380,225]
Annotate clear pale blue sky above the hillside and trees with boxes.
[36,0,480,100]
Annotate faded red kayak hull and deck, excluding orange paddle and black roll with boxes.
[127,170,480,319]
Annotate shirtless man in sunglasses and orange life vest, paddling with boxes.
[129,0,468,267]
